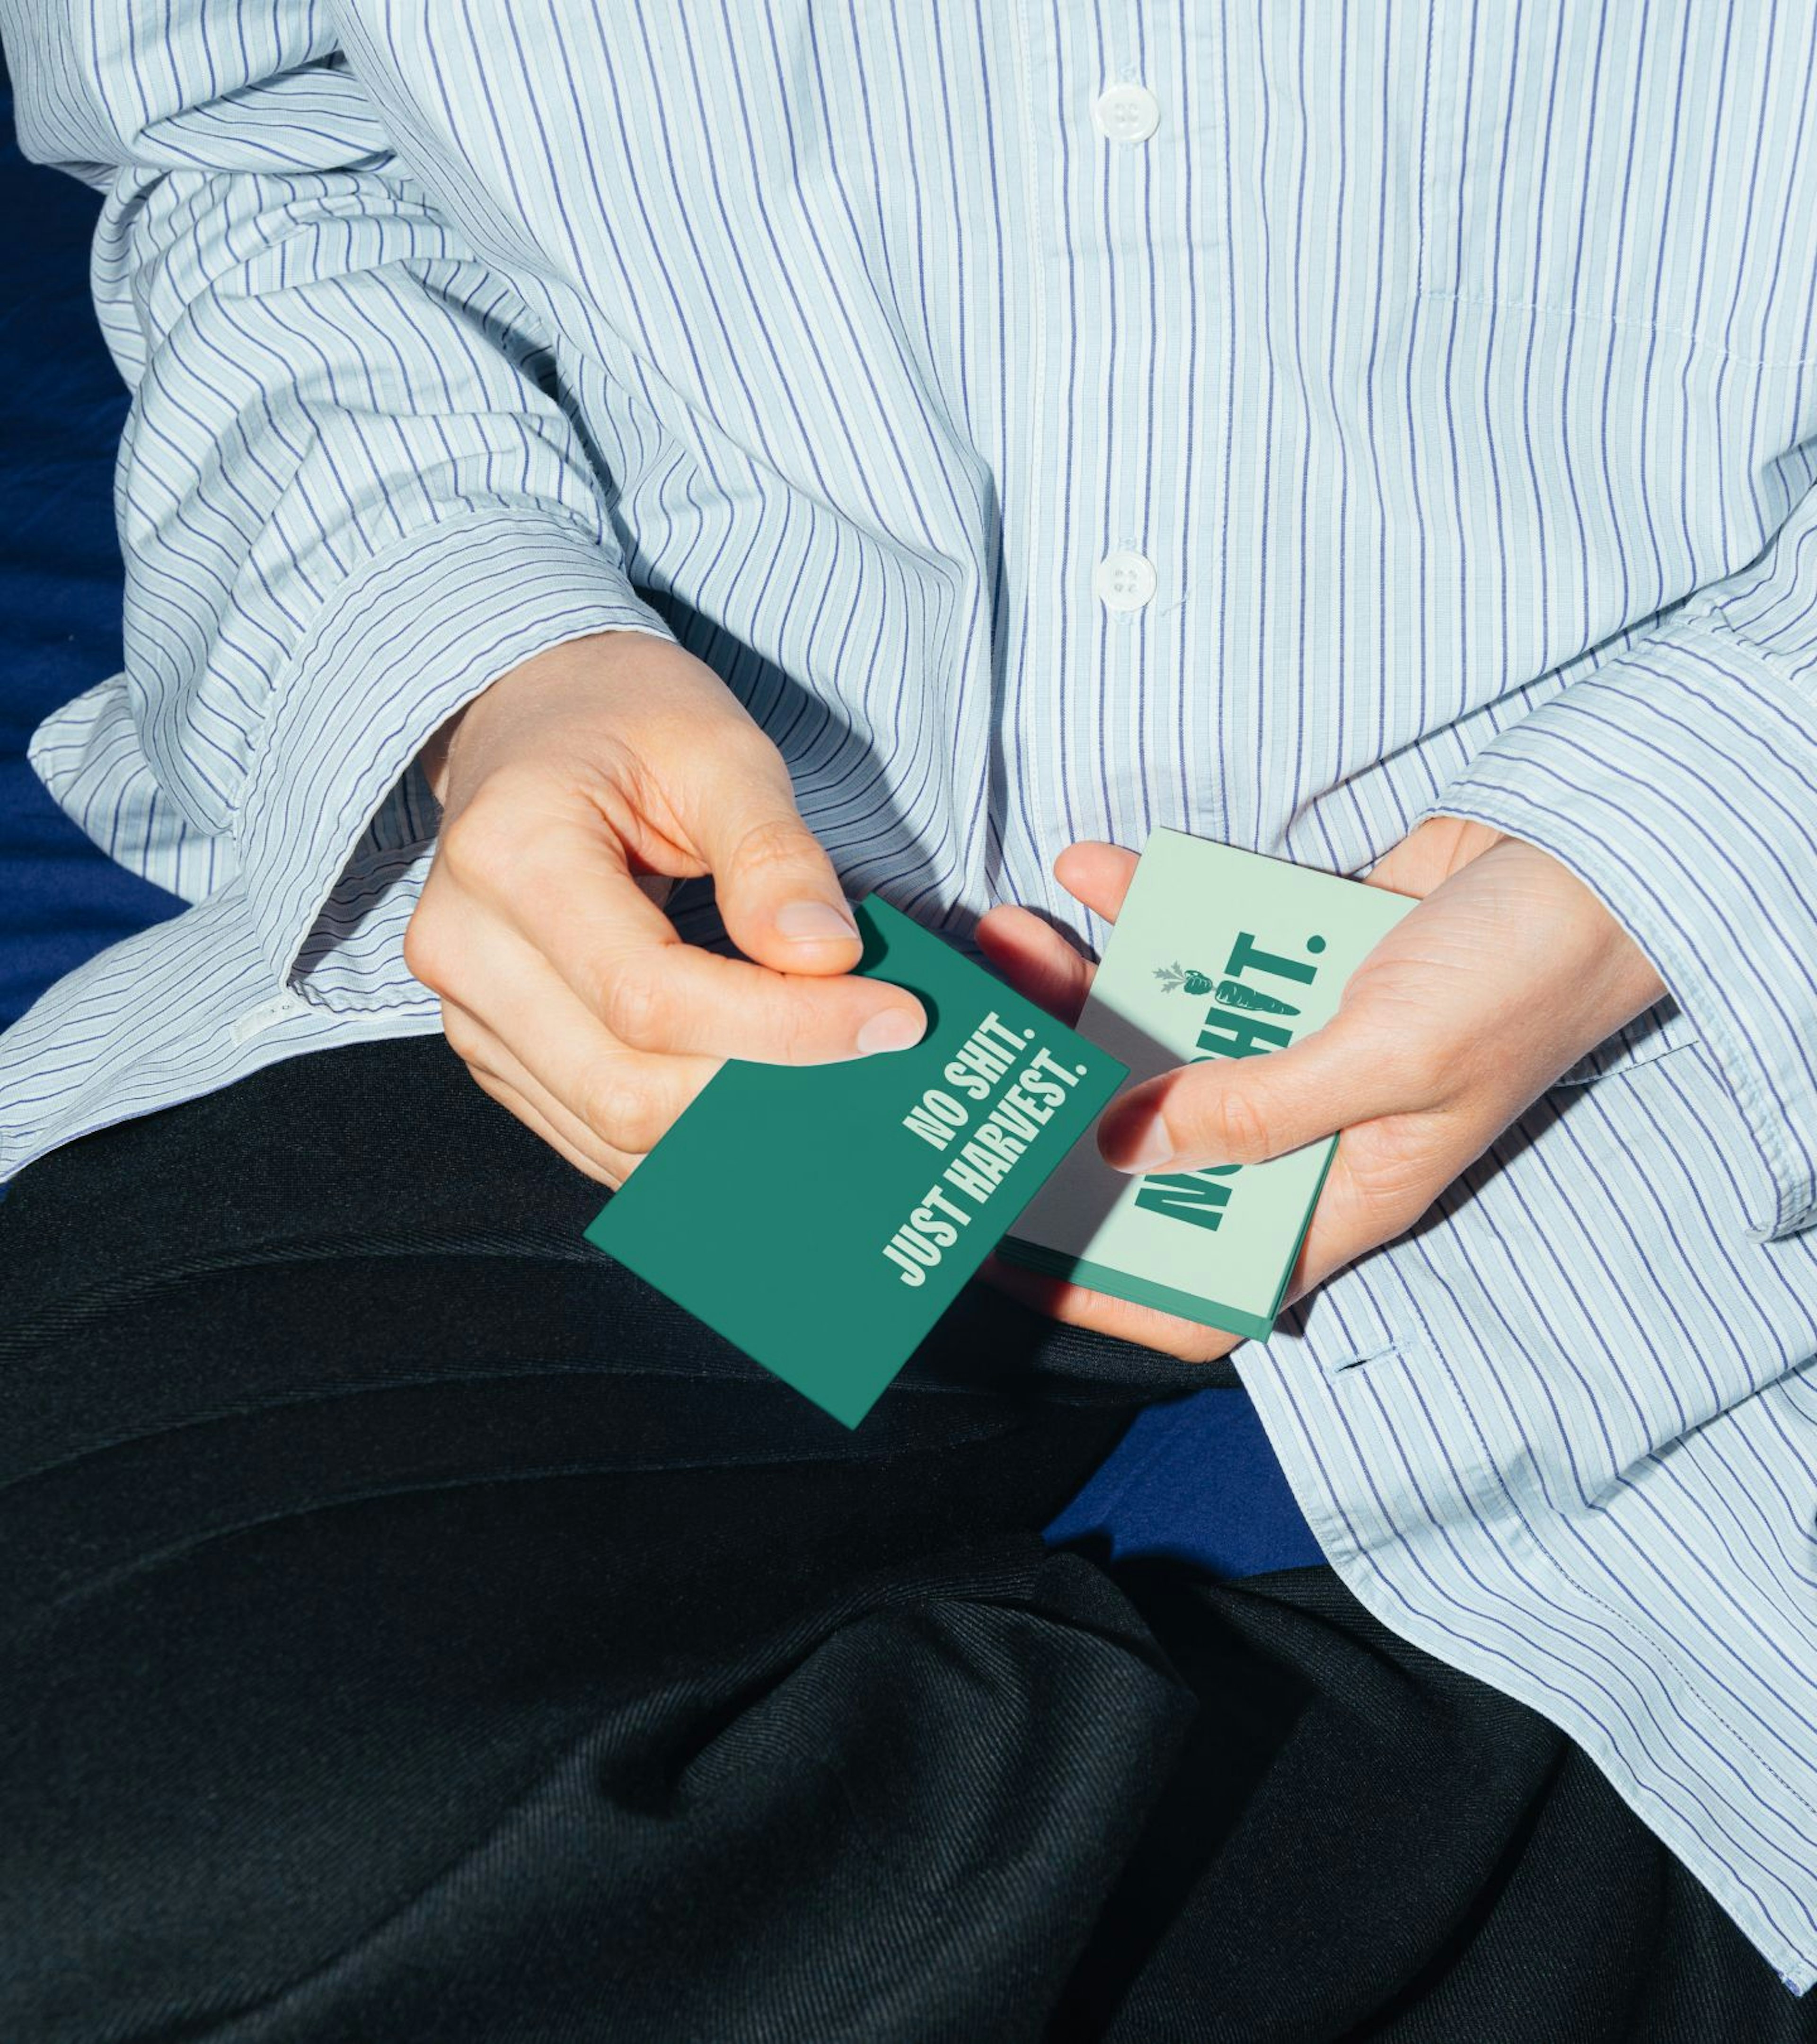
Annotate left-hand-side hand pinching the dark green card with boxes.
[405,632,926,1186]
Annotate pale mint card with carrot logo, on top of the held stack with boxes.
[997,830,1414,1339]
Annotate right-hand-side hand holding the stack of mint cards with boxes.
[977,816,1666,1361]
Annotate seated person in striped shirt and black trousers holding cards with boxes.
[0,0,1817,2044]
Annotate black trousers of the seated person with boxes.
[0,1039,1817,2044]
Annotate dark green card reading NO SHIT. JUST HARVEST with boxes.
[587,895,1126,1427]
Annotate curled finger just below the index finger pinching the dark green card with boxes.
[441,959,719,1155]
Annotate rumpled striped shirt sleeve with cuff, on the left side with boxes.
[0,0,666,1005]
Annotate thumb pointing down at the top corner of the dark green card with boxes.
[697,750,863,973]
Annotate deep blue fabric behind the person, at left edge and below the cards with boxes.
[0,78,1323,1576]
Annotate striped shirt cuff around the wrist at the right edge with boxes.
[1420,621,1817,1241]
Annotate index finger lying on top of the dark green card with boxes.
[458,801,928,1065]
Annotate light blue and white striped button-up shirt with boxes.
[0,0,1817,1989]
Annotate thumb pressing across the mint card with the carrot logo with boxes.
[1098,1014,1447,1173]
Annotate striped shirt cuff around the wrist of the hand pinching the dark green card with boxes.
[235,511,672,1008]
